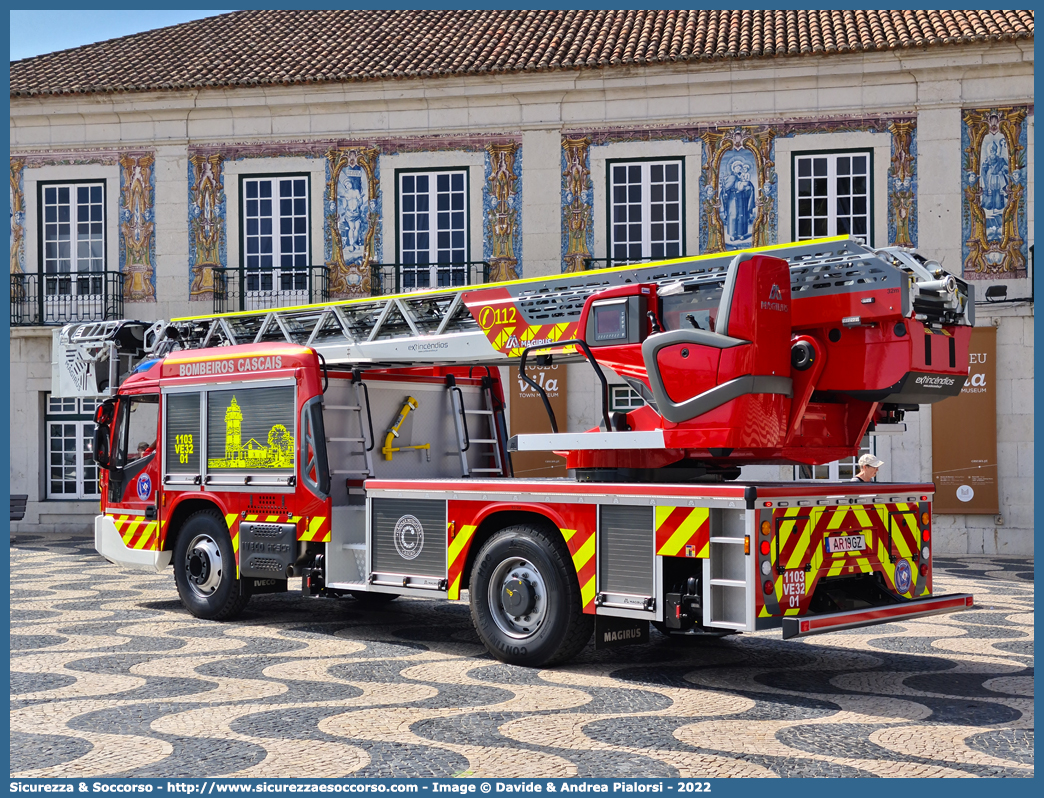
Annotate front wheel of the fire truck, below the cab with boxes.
[174,510,253,620]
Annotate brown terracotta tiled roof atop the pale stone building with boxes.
[10,10,1034,97]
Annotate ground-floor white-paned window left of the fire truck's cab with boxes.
[44,394,101,499]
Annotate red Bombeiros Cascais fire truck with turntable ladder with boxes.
[59,237,974,666]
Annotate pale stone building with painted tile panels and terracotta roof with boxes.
[10,11,1034,555]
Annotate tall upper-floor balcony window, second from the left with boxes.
[240,175,310,308]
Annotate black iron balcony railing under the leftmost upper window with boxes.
[10,272,124,327]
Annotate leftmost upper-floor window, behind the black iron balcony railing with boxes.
[40,183,105,311]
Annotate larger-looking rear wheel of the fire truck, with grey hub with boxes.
[469,524,594,667]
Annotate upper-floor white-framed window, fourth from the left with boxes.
[608,161,684,261]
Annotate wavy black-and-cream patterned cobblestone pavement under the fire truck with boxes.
[10,535,1034,777]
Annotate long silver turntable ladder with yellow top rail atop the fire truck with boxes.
[52,236,974,396]
